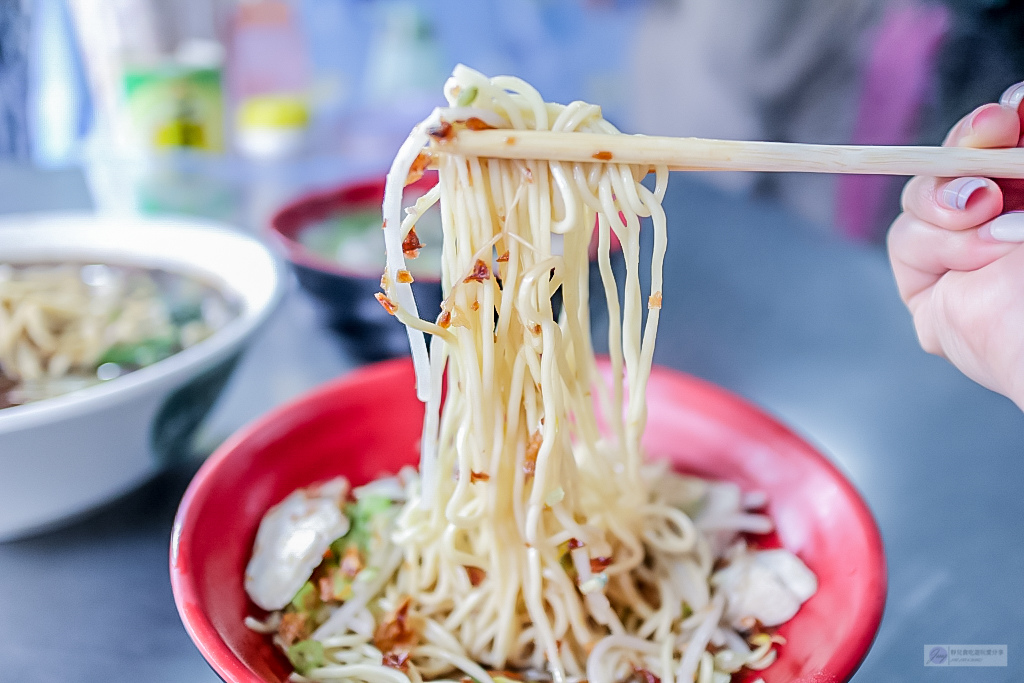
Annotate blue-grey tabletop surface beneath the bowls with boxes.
[0,162,1024,683]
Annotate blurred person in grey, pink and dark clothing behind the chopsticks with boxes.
[633,0,1024,242]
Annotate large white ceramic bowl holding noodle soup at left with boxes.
[0,214,284,540]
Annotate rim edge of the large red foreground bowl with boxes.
[170,358,888,683]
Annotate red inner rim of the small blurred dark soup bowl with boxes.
[266,178,440,283]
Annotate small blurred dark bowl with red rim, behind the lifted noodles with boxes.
[270,173,441,360]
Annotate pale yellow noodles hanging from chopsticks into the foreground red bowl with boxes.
[243,67,813,683]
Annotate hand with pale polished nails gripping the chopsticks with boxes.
[888,83,1024,410]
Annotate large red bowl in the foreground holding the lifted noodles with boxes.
[171,359,886,683]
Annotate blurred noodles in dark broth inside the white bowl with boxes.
[0,263,237,409]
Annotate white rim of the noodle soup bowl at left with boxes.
[0,213,287,435]
